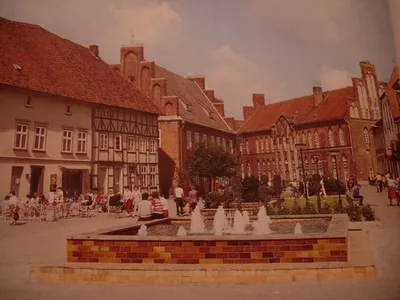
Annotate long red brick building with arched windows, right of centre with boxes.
[238,62,385,181]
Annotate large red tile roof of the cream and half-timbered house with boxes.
[0,18,159,114]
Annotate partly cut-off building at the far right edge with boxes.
[372,65,400,177]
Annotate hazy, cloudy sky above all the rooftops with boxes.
[0,0,395,119]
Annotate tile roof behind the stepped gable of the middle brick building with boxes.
[155,65,233,133]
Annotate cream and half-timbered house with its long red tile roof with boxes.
[0,18,159,196]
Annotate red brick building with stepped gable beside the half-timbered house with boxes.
[112,44,236,193]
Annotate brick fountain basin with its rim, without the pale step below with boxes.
[67,215,348,264]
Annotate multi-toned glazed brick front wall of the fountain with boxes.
[67,238,347,264]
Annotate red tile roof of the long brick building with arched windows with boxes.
[239,86,355,133]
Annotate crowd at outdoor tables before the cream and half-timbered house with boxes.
[1,182,199,225]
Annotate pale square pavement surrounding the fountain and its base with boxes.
[0,186,400,300]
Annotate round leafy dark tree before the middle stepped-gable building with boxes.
[188,142,237,191]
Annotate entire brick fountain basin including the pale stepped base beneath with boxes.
[30,215,376,286]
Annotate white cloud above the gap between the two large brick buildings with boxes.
[205,45,284,119]
